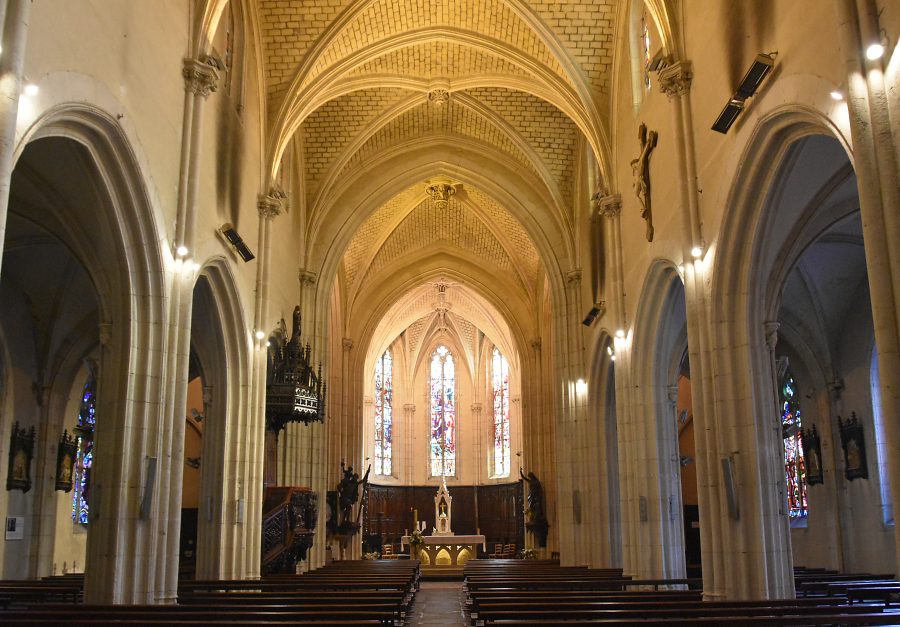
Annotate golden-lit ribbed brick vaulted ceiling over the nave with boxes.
[250,0,619,354]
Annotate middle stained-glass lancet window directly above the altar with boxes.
[431,346,456,477]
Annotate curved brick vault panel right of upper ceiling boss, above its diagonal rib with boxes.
[466,87,581,207]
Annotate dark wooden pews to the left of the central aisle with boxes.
[0,560,420,626]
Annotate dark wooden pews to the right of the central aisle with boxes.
[465,560,900,626]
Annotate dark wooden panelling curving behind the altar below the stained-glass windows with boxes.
[363,481,525,550]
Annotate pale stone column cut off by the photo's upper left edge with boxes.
[0,0,31,274]
